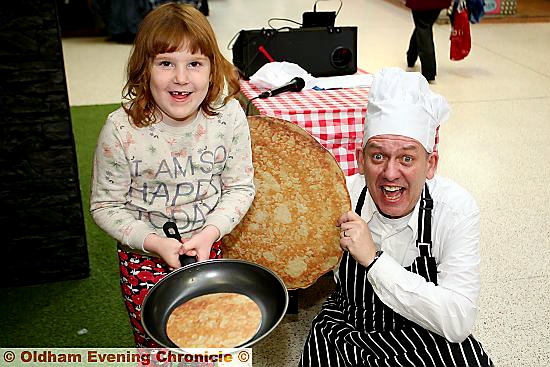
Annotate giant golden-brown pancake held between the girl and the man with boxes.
[223,116,351,289]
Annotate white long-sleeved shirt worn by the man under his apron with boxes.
[347,175,480,342]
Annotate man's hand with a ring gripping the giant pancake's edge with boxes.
[338,211,376,267]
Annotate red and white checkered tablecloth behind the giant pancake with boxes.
[241,80,369,176]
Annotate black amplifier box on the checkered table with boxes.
[233,27,357,79]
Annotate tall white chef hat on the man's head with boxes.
[363,68,450,153]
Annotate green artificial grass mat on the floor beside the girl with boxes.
[0,105,134,348]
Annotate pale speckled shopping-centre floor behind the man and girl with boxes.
[63,0,550,367]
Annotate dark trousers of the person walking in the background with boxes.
[407,9,441,80]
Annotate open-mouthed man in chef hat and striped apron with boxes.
[300,68,492,367]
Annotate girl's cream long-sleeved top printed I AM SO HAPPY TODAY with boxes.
[90,100,255,251]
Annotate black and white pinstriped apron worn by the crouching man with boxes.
[300,185,493,367]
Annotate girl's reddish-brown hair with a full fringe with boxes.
[122,4,240,127]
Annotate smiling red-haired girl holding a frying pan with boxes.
[90,4,255,348]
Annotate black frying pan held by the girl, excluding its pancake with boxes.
[141,222,288,348]
